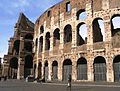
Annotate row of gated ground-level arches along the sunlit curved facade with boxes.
[41,55,120,82]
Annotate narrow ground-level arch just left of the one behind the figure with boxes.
[52,61,58,80]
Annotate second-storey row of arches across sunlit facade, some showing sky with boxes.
[36,14,120,51]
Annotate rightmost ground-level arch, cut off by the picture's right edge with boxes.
[113,55,120,82]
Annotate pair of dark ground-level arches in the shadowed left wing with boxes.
[8,55,33,78]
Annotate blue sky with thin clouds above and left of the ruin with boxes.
[0,0,63,58]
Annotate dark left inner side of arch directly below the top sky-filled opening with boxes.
[77,23,85,46]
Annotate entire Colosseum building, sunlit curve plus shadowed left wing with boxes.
[3,0,120,82]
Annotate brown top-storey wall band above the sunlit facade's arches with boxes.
[35,0,120,33]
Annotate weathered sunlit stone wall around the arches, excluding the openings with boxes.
[34,0,120,82]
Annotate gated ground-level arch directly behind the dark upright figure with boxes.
[63,59,72,81]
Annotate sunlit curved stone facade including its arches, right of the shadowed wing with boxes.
[34,0,120,82]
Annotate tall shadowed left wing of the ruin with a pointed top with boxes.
[2,13,34,79]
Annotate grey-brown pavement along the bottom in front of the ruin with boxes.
[0,80,120,91]
